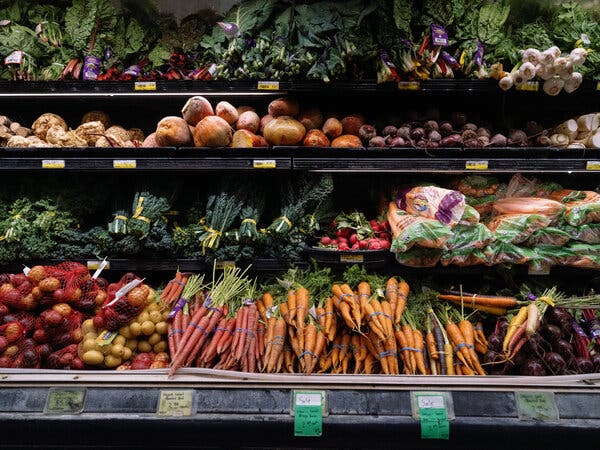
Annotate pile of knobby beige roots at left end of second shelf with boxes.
[0,111,145,148]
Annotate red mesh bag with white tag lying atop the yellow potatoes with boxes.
[94,273,148,331]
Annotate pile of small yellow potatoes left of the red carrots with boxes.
[79,300,169,369]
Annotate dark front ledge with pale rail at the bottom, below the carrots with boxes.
[0,369,600,449]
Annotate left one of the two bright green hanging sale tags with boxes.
[292,391,325,437]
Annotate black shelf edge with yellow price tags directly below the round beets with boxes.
[0,146,600,173]
